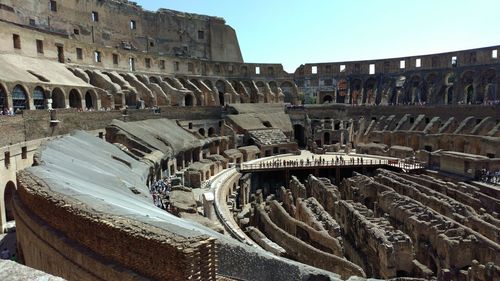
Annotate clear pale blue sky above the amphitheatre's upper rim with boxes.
[136,0,500,72]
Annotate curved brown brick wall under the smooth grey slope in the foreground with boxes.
[16,172,217,280]
